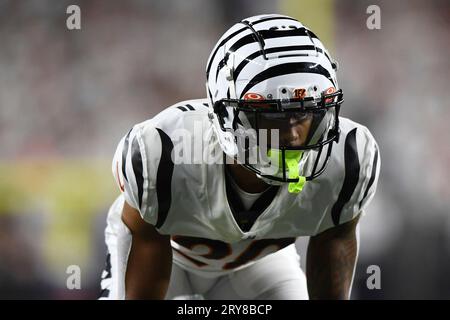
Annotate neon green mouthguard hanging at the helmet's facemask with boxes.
[267,149,306,193]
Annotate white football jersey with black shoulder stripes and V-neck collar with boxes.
[110,100,380,275]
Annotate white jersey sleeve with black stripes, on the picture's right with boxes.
[318,126,381,233]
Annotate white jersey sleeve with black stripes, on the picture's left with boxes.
[112,122,161,225]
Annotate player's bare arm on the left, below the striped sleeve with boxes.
[122,202,172,299]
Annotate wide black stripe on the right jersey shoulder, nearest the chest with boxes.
[331,128,359,226]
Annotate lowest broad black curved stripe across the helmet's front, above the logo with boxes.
[241,62,334,98]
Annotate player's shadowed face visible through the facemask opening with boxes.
[260,112,312,147]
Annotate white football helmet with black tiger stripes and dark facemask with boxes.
[206,15,343,192]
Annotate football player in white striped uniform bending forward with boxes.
[101,15,380,299]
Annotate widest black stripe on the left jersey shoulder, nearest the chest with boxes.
[155,128,174,229]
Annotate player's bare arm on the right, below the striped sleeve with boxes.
[306,216,359,299]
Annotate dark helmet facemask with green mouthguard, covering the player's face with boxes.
[214,88,343,193]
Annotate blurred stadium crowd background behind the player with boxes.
[0,0,450,299]
